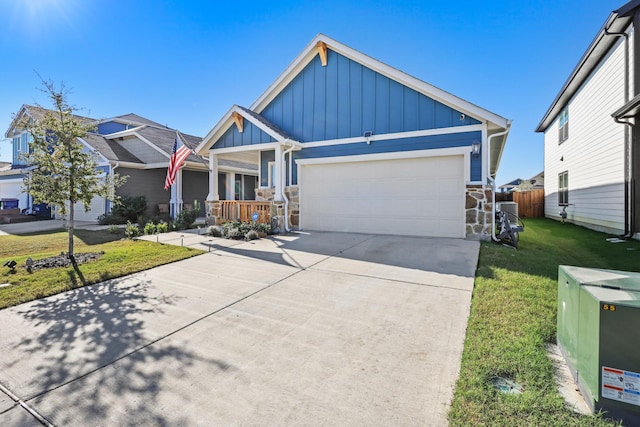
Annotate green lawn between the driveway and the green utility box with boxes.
[449,219,640,426]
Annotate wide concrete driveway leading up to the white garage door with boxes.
[0,233,479,426]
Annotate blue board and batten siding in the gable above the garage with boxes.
[260,50,480,142]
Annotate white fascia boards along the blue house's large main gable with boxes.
[249,34,508,129]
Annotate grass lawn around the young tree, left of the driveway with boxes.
[0,230,202,309]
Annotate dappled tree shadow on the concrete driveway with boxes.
[2,280,230,425]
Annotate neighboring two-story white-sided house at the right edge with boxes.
[536,0,640,236]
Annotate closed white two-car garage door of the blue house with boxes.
[300,156,465,238]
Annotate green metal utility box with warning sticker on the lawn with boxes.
[557,265,640,425]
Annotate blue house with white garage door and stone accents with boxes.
[196,34,511,238]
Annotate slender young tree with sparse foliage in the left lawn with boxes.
[22,80,125,265]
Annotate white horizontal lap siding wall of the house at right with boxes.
[544,33,633,232]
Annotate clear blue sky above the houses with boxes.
[0,0,625,185]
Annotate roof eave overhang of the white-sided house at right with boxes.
[536,0,640,132]
